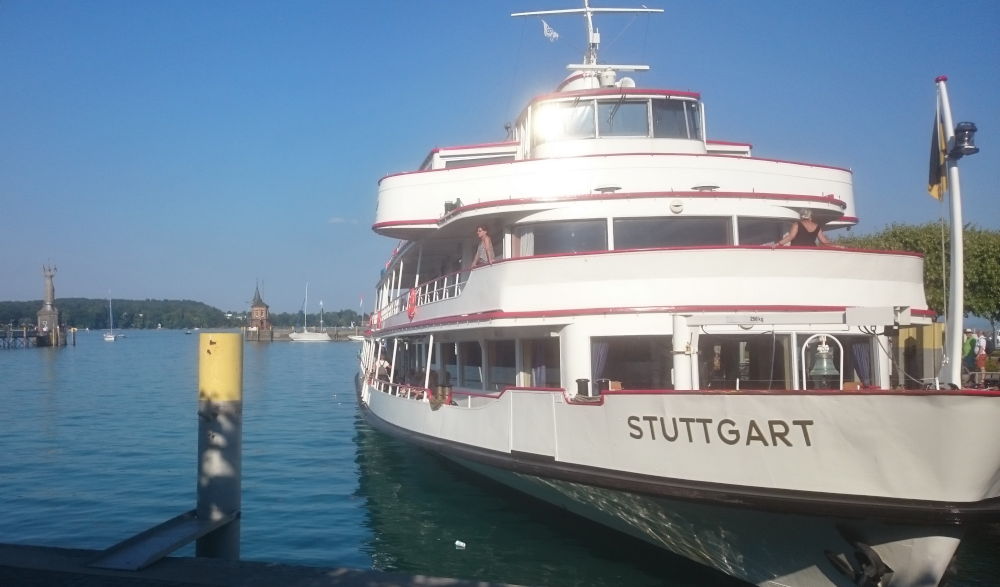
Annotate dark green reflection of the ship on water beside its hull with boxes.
[355,417,744,586]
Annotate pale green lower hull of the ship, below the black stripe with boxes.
[453,459,962,586]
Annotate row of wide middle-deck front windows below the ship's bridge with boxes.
[511,216,791,257]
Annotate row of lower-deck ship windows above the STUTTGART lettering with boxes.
[378,334,874,391]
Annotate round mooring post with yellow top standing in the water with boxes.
[195,333,243,560]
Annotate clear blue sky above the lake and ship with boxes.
[0,0,1000,312]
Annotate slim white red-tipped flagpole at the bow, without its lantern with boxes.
[934,75,965,387]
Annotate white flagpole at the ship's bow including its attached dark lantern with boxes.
[934,75,979,386]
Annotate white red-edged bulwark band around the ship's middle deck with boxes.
[373,245,929,331]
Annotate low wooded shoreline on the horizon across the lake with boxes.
[0,298,361,330]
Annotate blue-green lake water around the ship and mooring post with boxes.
[0,331,1000,587]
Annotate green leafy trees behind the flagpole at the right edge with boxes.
[837,223,1000,330]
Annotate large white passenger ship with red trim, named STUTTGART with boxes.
[358,1,1000,585]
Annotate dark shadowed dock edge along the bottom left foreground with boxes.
[0,544,516,587]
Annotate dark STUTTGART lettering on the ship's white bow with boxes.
[627,416,815,446]
